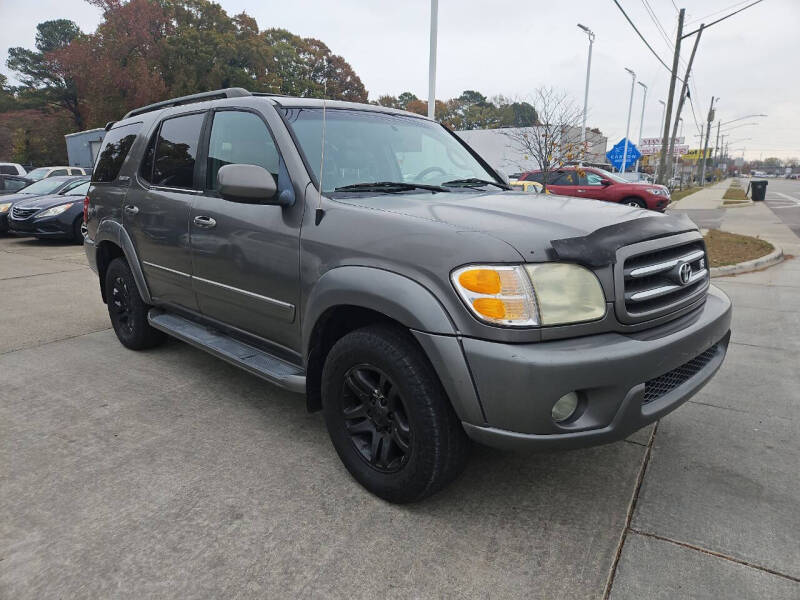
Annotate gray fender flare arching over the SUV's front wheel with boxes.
[302,266,456,353]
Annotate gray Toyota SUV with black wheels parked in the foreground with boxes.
[84,88,731,502]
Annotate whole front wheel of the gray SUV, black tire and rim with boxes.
[322,325,468,503]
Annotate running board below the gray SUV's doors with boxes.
[147,308,306,394]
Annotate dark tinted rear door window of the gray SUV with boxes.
[152,114,205,189]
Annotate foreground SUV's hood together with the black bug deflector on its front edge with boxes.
[337,192,696,264]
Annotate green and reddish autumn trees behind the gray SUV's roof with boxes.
[0,0,367,163]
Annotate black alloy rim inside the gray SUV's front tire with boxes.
[342,364,412,473]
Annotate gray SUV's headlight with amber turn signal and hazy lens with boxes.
[452,263,606,327]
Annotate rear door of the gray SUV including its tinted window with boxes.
[123,111,207,310]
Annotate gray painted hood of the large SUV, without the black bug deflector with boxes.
[336,192,685,261]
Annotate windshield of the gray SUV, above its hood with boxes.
[278,108,497,192]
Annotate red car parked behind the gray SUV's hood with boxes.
[522,167,670,212]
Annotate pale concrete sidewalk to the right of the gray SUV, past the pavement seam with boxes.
[611,198,800,600]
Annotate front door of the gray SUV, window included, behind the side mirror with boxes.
[189,109,302,348]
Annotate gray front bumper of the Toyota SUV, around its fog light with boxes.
[462,286,731,448]
